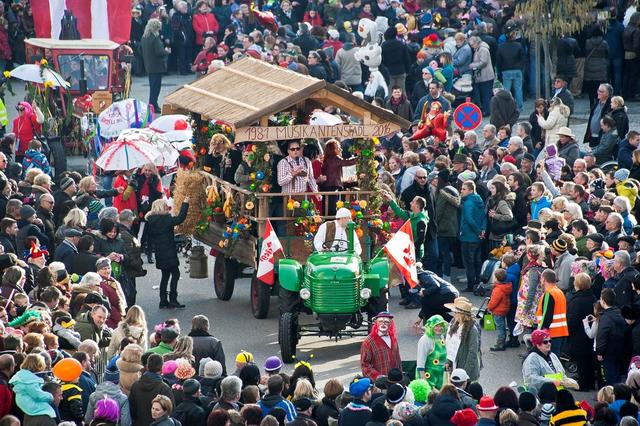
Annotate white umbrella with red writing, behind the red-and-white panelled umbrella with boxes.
[98,99,149,138]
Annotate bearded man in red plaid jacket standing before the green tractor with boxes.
[360,312,402,381]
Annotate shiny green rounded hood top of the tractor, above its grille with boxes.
[305,252,362,280]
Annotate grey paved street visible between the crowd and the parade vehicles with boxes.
[6,76,640,393]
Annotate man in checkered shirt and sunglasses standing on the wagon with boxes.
[278,141,318,194]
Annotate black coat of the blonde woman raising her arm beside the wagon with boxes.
[147,203,189,269]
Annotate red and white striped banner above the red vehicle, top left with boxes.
[31,0,131,43]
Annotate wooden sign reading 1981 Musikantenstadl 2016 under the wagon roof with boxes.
[235,122,400,142]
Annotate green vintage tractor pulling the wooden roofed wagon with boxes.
[278,223,389,363]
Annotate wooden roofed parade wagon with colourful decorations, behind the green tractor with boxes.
[162,58,411,318]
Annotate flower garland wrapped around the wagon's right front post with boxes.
[349,138,382,212]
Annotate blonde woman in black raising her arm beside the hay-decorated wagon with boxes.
[145,197,189,309]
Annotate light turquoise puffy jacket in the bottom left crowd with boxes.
[9,370,56,419]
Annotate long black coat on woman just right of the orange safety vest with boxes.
[564,288,596,359]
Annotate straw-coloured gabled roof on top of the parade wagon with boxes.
[164,57,409,128]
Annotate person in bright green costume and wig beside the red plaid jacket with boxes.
[416,315,448,389]
